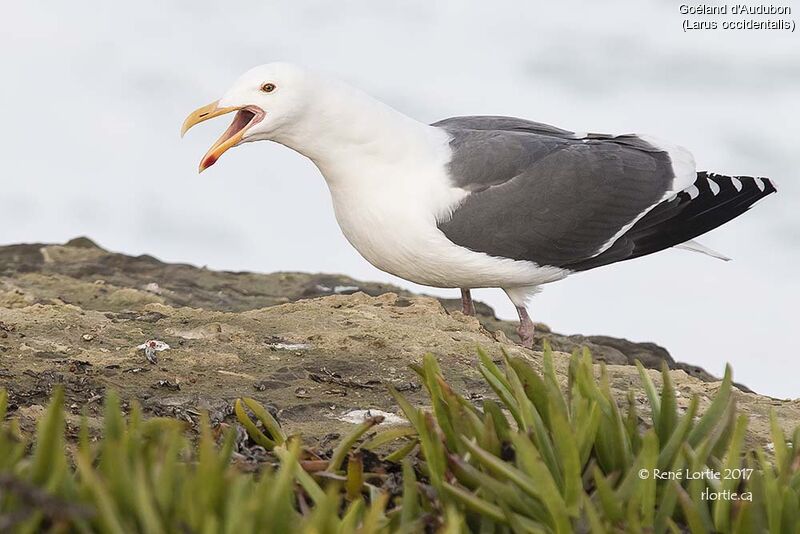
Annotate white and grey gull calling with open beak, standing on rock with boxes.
[181,62,776,347]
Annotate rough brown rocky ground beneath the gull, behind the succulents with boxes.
[0,238,800,448]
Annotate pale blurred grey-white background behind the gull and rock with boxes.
[0,0,800,398]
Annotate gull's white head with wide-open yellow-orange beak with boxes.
[181,63,313,172]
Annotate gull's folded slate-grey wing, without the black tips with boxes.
[434,116,675,269]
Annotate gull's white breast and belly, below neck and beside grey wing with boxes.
[320,134,568,294]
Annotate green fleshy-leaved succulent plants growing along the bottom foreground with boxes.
[0,347,800,534]
